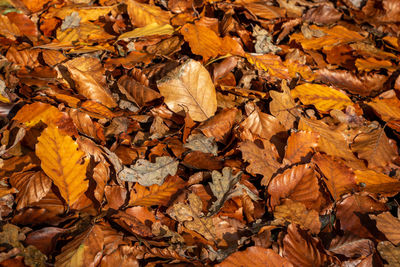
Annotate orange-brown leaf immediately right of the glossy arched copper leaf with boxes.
[313,153,357,200]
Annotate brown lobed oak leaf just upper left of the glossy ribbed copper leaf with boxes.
[239,141,280,185]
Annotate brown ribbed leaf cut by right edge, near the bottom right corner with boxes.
[369,212,400,246]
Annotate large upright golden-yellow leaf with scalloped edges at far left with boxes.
[36,125,89,205]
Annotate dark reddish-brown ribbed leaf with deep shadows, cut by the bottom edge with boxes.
[283,224,332,267]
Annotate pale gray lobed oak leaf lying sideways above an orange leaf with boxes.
[118,156,179,186]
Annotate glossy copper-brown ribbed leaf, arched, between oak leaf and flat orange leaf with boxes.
[268,164,322,210]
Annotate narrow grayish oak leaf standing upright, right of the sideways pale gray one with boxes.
[209,167,242,216]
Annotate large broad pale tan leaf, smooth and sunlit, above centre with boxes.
[157,60,217,121]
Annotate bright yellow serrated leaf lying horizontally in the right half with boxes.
[291,83,353,112]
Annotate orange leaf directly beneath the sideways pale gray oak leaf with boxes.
[129,176,185,207]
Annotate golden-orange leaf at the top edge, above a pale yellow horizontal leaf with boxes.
[127,0,171,27]
